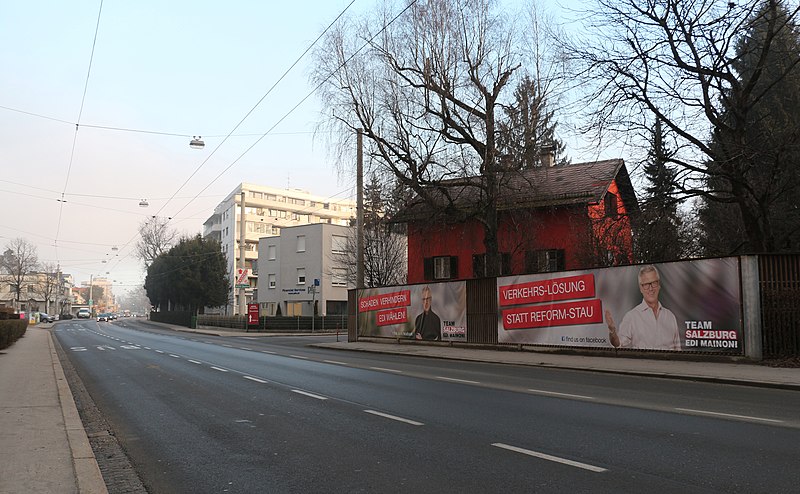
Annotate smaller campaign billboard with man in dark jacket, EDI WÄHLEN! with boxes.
[358,281,467,341]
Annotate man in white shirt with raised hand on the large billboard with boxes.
[605,265,681,350]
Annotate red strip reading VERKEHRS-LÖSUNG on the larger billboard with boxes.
[499,274,594,307]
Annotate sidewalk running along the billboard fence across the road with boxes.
[175,325,800,391]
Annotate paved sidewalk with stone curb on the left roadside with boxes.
[0,324,107,494]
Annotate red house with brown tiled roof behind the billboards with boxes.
[395,159,639,283]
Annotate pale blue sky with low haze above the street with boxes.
[0,0,588,294]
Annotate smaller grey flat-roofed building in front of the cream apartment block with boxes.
[258,224,352,316]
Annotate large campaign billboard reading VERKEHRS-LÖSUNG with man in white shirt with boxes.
[497,258,744,354]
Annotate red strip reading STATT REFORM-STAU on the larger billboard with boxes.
[502,299,603,329]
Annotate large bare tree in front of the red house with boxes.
[312,0,564,274]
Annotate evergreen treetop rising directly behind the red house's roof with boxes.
[497,75,569,170]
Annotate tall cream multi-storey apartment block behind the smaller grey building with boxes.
[203,182,356,314]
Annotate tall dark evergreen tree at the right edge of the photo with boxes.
[699,0,800,255]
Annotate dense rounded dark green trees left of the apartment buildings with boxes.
[145,235,230,312]
